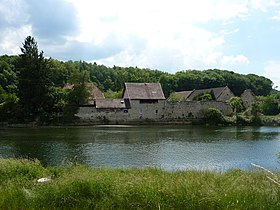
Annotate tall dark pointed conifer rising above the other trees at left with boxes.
[18,36,51,120]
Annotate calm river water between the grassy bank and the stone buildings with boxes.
[0,126,280,171]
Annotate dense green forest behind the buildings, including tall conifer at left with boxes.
[0,36,275,124]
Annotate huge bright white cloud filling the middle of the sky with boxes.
[64,0,252,71]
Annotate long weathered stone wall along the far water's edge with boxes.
[76,100,233,124]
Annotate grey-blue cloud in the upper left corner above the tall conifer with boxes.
[0,0,79,54]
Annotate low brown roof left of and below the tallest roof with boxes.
[95,98,126,109]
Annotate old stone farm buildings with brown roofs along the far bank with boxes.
[76,83,255,124]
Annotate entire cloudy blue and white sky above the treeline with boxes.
[0,0,280,89]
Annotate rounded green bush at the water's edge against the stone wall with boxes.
[201,108,225,124]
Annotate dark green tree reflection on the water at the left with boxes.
[1,128,87,165]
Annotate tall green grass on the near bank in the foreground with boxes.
[0,159,280,209]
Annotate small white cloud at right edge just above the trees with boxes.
[264,61,280,90]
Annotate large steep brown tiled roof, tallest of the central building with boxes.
[123,83,165,100]
